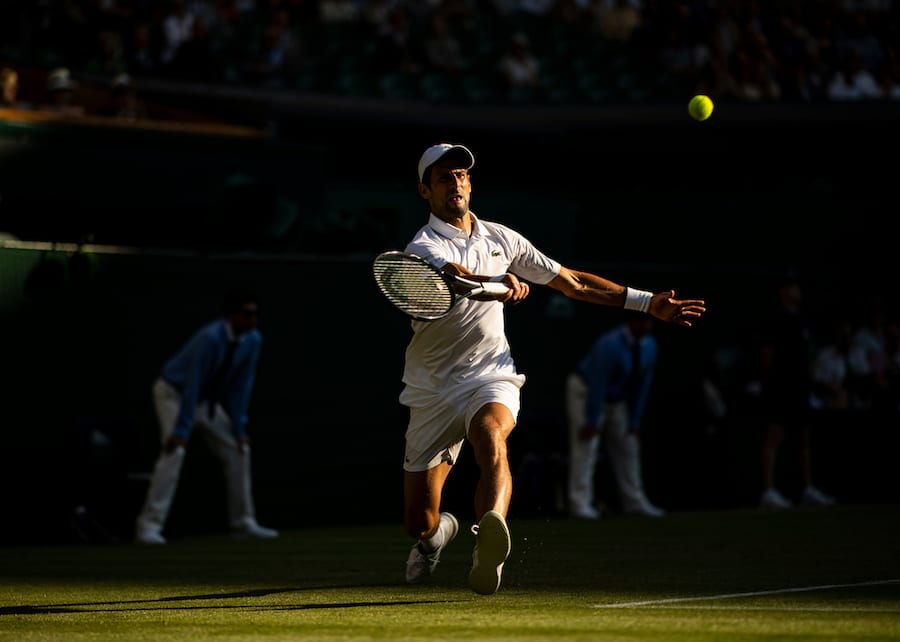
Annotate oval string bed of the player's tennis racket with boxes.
[373,257,454,319]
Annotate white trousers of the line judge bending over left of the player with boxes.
[137,379,256,533]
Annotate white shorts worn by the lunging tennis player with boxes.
[401,380,522,472]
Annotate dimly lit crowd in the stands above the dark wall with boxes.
[0,0,900,114]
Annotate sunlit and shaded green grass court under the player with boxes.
[0,504,900,642]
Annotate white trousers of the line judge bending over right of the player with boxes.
[566,373,650,513]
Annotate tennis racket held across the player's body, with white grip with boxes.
[372,251,509,321]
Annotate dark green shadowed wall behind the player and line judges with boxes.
[0,102,898,541]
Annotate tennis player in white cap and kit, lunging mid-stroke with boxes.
[400,143,706,595]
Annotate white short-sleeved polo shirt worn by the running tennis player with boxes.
[400,214,560,405]
